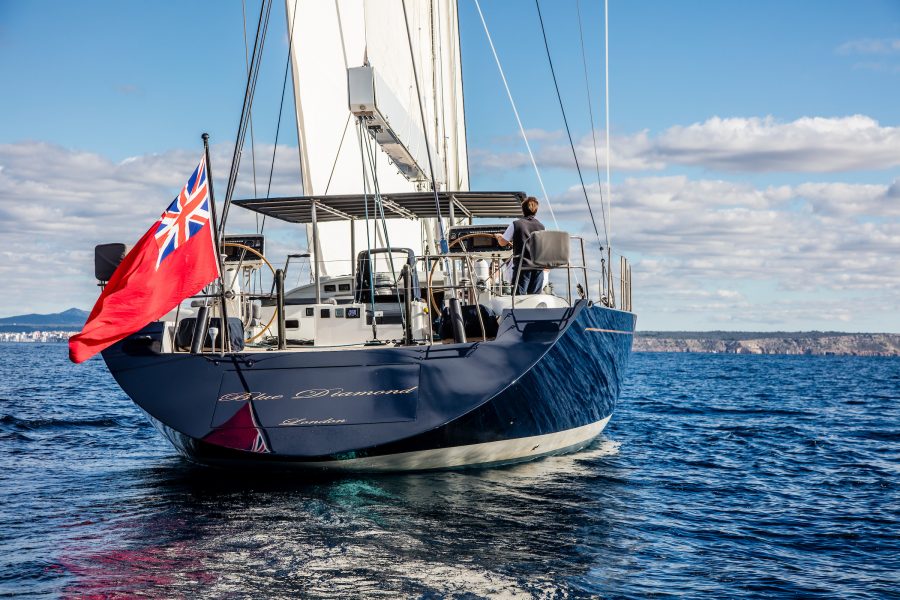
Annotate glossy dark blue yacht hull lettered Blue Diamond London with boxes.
[104,301,635,470]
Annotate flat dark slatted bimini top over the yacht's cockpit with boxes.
[234,192,527,223]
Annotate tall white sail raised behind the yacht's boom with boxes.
[286,0,469,274]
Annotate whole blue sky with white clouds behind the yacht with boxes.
[0,0,900,332]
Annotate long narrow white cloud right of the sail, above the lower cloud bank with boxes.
[471,115,900,173]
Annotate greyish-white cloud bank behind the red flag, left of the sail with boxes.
[0,142,299,315]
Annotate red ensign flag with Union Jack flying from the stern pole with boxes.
[69,158,219,363]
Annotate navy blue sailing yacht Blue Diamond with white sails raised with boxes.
[97,0,636,471]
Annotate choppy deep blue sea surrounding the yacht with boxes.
[0,344,900,598]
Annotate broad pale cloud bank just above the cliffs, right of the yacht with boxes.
[553,176,900,329]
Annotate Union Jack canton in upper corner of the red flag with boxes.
[155,157,210,269]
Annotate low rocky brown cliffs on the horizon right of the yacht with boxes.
[633,331,900,356]
